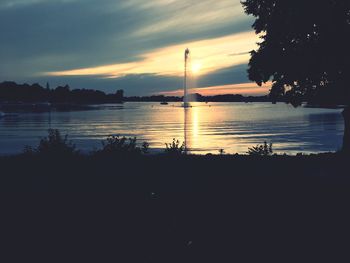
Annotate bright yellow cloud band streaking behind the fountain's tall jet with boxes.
[43,32,257,78]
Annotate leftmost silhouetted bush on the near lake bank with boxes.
[24,129,79,156]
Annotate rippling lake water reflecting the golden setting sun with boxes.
[0,102,344,154]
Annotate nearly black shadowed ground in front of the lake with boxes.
[0,154,350,263]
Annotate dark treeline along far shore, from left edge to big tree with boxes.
[0,81,271,104]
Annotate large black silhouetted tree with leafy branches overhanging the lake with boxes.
[242,0,350,152]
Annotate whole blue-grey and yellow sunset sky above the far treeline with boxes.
[0,0,268,96]
